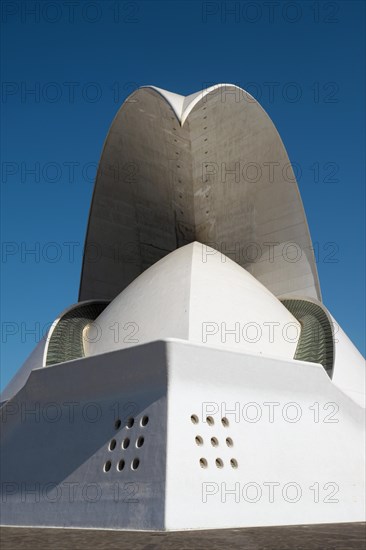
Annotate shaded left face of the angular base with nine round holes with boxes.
[0,343,167,529]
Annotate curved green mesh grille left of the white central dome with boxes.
[46,302,108,366]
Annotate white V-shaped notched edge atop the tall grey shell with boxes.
[139,83,256,126]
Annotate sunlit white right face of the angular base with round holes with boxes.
[165,342,365,530]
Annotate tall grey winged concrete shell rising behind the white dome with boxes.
[79,84,321,300]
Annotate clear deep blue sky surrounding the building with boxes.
[1,0,365,386]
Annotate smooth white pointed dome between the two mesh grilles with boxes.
[84,242,301,359]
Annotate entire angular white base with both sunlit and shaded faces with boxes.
[1,340,365,530]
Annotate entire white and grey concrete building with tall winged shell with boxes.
[0,85,365,536]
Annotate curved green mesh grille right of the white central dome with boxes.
[281,299,334,376]
